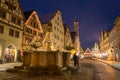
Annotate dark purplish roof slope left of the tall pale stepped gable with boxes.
[40,10,58,24]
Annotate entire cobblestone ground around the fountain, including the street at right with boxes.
[0,60,120,80]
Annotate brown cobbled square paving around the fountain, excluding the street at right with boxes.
[0,63,93,80]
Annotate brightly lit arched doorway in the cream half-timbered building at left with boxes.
[4,45,17,62]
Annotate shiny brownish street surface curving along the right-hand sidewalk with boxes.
[80,60,120,80]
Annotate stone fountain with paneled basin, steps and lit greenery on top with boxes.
[7,30,70,75]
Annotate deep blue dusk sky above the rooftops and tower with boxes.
[20,0,120,50]
